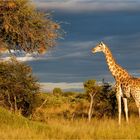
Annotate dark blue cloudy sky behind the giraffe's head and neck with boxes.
[27,0,140,91]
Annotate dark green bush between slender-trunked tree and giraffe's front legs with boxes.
[93,83,117,118]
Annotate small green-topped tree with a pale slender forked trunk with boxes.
[84,80,99,121]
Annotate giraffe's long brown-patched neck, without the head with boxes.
[104,47,130,80]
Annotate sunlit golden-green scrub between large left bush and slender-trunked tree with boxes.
[32,93,88,121]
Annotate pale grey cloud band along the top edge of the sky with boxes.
[32,0,140,12]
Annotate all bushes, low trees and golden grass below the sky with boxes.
[0,60,140,139]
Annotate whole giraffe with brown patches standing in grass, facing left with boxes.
[92,42,140,124]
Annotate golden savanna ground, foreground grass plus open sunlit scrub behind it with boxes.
[0,88,140,140]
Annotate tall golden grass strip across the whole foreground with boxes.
[0,108,140,140]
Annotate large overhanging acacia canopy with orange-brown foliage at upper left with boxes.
[0,0,62,53]
